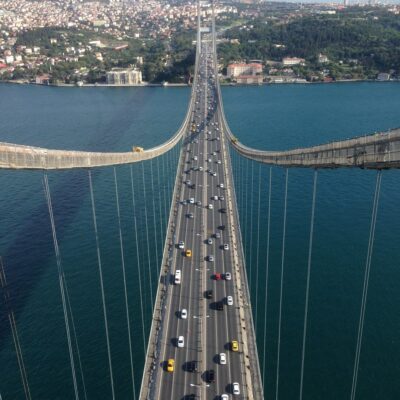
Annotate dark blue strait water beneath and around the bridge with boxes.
[0,83,400,400]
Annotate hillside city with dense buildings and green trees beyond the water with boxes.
[0,0,400,86]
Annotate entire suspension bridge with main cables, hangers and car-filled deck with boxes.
[0,2,400,400]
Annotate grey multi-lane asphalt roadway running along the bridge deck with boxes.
[156,36,246,400]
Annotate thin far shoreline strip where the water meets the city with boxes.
[0,79,400,88]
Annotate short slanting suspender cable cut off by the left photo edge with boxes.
[0,257,32,400]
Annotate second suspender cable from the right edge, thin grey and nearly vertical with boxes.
[299,169,318,400]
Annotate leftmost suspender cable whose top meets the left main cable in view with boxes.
[43,173,79,400]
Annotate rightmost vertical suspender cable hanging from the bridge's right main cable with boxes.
[350,170,382,400]
